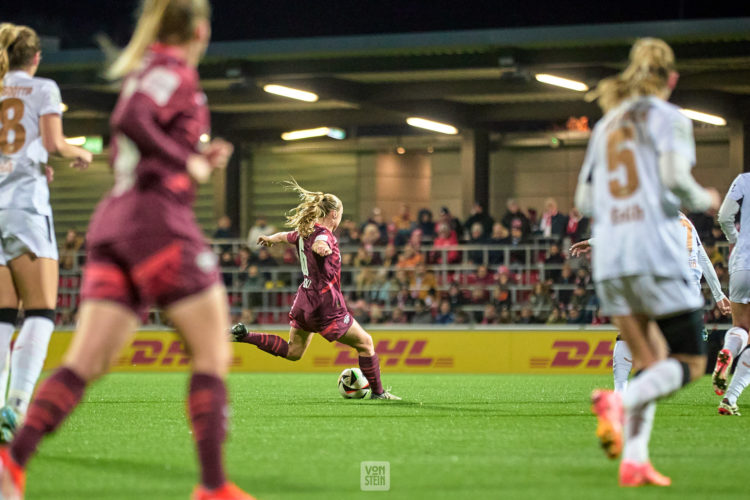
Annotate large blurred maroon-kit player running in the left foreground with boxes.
[0,0,252,500]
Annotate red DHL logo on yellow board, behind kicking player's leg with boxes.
[313,340,453,368]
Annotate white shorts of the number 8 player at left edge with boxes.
[0,209,58,266]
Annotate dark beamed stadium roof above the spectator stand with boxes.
[40,18,750,141]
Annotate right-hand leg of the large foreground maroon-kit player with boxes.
[167,284,252,500]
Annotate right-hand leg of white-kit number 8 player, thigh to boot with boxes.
[0,254,58,433]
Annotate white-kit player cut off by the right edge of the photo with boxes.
[712,174,750,415]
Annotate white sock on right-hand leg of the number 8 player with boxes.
[7,316,55,415]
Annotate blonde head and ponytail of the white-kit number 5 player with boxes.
[586,38,675,113]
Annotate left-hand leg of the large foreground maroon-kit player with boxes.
[0,301,138,498]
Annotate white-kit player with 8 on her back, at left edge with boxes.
[0,23,92,442]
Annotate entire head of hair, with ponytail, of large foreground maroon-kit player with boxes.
[107,0,211,80]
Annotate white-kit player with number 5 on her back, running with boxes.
[576,38,719,486]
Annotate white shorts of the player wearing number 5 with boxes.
[596,275,703,318]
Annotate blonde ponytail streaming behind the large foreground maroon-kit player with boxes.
[107,0,170,80]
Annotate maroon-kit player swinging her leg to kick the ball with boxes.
[232,181,401,399]
